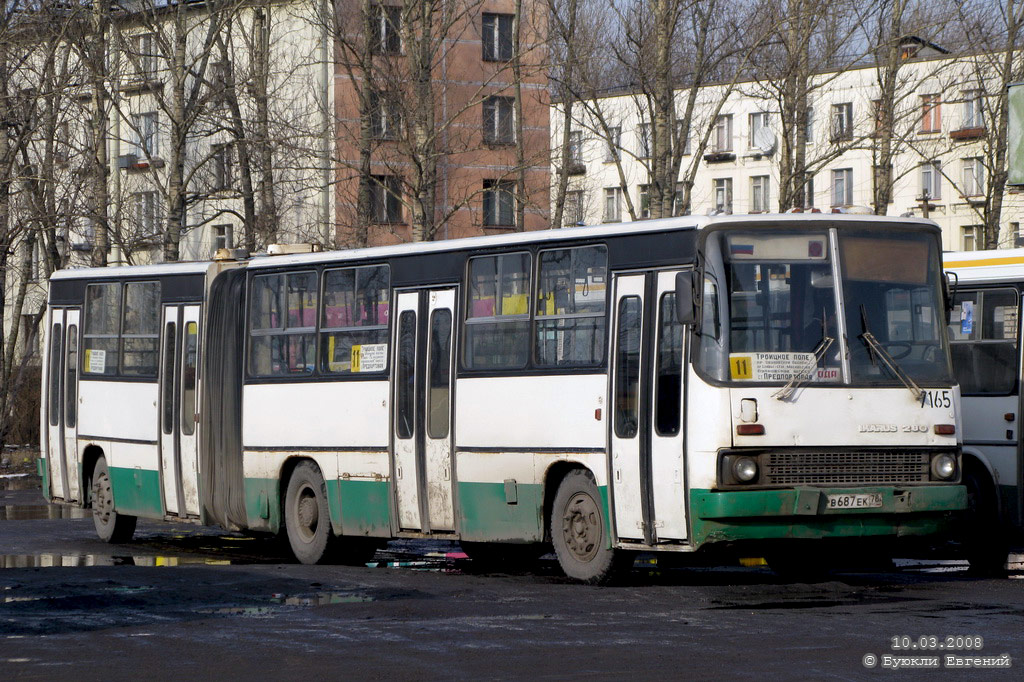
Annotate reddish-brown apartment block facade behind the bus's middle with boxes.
[334,0,550,246]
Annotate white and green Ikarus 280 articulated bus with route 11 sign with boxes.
[40,215,967,583]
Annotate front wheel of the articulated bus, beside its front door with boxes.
[550,469,632,585]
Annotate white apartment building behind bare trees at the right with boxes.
[552,45,1024,250]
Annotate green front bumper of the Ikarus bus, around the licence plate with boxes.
[690,485,967,547]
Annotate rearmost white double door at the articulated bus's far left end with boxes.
[46,308,81,502]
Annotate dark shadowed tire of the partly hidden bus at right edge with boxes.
[962,465,1010,576]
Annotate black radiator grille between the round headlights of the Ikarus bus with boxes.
[764,451,929,485]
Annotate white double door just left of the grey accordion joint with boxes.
[160,305,200,516]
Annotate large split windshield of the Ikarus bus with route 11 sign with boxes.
[701,227,951,385]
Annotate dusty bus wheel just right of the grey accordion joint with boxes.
[285,462,333,563]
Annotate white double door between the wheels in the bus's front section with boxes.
[392,289,456,532]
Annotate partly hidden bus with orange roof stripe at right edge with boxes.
[943,249,1024,568]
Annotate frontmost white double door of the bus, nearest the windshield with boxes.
[608,270,687,544]
